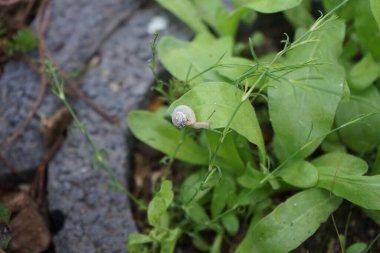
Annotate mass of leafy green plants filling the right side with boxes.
[128,0,380,253]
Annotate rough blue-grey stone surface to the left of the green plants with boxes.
[0,0,188,253]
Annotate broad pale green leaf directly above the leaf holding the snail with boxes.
[158,34,233,84]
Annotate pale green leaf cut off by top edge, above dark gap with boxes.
[244,0,302,13]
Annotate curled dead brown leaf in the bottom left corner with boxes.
[0,192,51,253]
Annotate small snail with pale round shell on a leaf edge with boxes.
[172,105,209,129]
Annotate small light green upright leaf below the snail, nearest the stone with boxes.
[148,180,173,227]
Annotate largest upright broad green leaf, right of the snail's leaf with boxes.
[268,20,345,160]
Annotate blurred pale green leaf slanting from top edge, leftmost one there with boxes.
[157,0,208,33]
